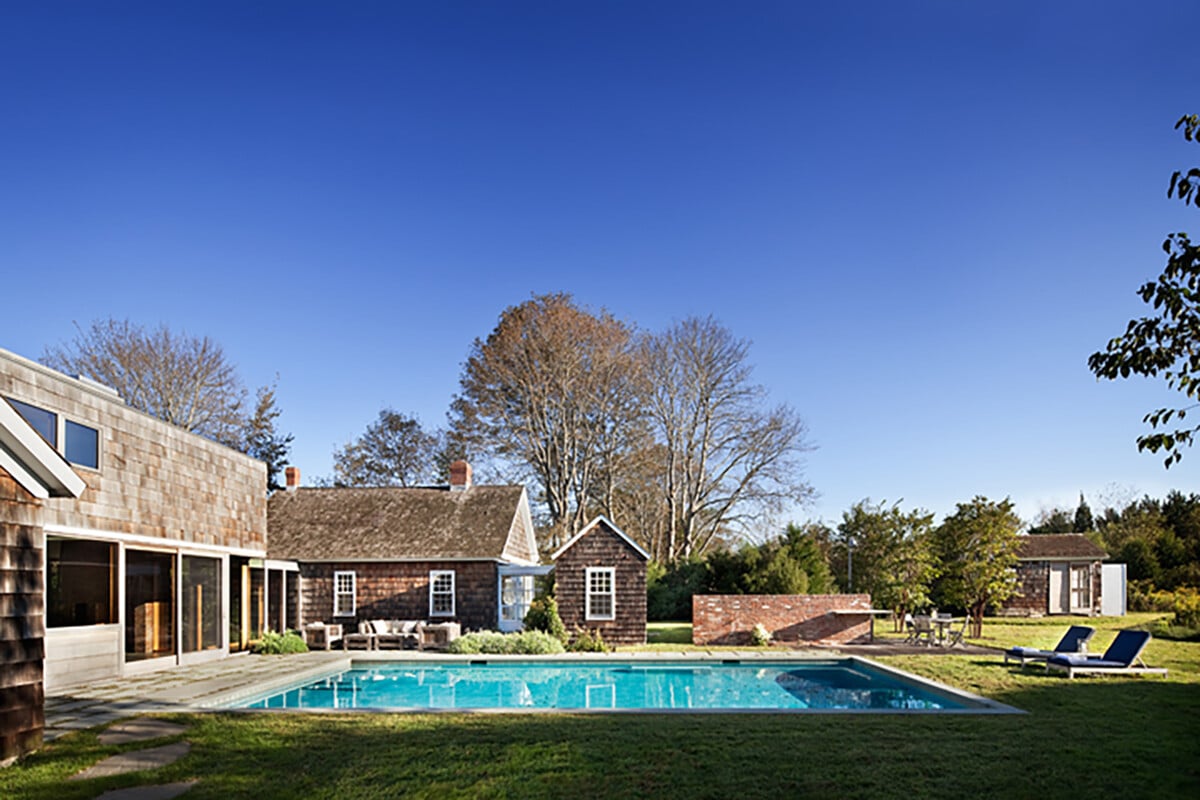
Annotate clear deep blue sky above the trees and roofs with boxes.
[0,1,1200,532]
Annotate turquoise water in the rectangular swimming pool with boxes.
[241,660,983,711]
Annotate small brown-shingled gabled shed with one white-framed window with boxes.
[551,516,650,644]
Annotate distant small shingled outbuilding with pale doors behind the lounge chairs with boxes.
[1000,534,1108,616]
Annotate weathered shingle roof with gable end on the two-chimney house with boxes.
[266,486,538,561]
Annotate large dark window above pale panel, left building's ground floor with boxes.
[46,536,116,627]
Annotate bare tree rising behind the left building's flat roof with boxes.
[42,319,246,449]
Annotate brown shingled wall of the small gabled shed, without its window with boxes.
[554,522,646,644]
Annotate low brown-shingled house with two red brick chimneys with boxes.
[268,462,547,631]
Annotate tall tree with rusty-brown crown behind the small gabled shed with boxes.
[451,294,637,546]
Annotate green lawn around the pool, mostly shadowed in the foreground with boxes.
[0,615,1200,800]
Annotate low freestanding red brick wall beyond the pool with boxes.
[691,595,871,644]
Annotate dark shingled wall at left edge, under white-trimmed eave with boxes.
[0,469,44,764]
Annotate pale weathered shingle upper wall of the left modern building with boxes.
[0,353,266,549]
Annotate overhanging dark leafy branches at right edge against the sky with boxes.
[1087,114,1200,468]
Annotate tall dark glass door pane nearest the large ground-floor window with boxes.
[125,549,175,661]
